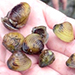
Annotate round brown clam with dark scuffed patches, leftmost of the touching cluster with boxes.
[2,32,24,53]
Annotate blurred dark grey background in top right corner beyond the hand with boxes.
[41,0,75,19]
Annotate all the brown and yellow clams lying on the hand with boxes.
[1,2,75,71]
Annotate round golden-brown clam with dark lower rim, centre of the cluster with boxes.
[22,34,44,54]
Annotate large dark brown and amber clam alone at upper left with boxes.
[1,2,30,30]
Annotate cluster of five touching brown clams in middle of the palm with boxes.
[2,26,55,71]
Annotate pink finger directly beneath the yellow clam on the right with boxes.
[47,30,75,56]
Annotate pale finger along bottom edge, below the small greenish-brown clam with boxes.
[23,64,60,75]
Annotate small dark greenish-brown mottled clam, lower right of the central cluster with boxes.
[39,49,55,67]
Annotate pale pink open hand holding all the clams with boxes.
[0,0,75,75]
